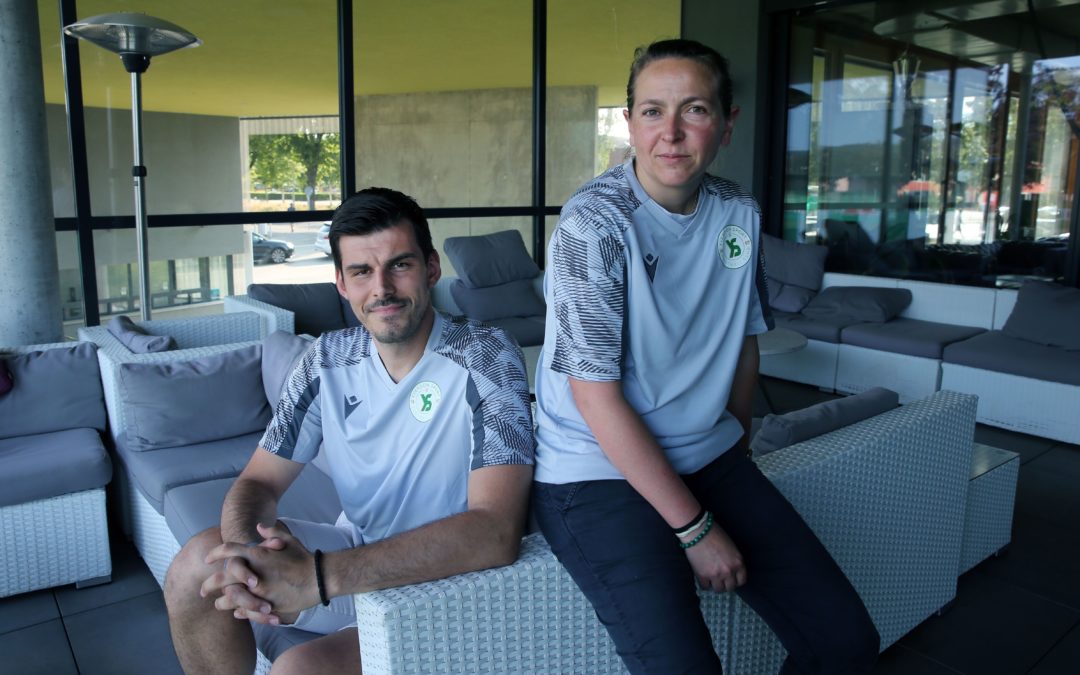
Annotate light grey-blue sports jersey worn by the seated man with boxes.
[259,312,534,544]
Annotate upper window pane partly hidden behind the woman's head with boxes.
[545,0,681,205]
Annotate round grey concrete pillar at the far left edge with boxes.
[0,0,64,346]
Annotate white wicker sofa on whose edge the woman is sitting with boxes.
[355,392,993,674]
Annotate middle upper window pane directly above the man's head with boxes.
[353,0,532,208]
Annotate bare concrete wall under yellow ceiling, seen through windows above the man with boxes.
[356,86,596,207]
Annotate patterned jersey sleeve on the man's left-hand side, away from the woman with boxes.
[259,337,323,462]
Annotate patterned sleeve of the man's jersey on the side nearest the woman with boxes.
[465,325,536,469]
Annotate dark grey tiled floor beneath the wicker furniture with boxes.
[0,379,1080,675]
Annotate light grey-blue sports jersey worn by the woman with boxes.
[536,162,769,483]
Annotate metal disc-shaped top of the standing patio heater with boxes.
[64,12,202,57]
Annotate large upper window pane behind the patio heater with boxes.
[70,0,339,216]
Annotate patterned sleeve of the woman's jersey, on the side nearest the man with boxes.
[549,201,626,382]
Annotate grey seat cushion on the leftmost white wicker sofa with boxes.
[0,429,112,507]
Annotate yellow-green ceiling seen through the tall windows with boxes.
[38,0,680,117]
